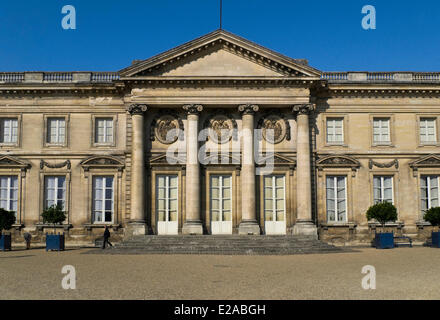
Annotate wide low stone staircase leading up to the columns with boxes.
[102,235,348,255]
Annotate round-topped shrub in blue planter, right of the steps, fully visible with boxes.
[367,202,397,249]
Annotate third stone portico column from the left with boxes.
[238,105,260,235]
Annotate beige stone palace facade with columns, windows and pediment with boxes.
[0,30,440,244]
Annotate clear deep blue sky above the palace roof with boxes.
[0,0,440,71]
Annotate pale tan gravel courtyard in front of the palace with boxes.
[0,247,440,300]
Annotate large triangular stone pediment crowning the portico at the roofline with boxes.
[120,30,321,80]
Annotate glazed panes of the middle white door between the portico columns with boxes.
[211,175,232,221]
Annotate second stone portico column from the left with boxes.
[182,105,203,234]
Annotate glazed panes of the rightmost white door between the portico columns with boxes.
[264,175,286,222]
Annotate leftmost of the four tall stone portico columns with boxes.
[127,104,148,235]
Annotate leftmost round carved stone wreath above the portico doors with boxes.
[150,112,183,144]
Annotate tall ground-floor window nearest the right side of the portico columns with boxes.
[326,176,347,222]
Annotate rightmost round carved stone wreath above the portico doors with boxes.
[258,113,290,144]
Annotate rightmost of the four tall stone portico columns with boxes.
[293,104,318,238]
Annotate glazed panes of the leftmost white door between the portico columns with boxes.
[156,175,178,222]
